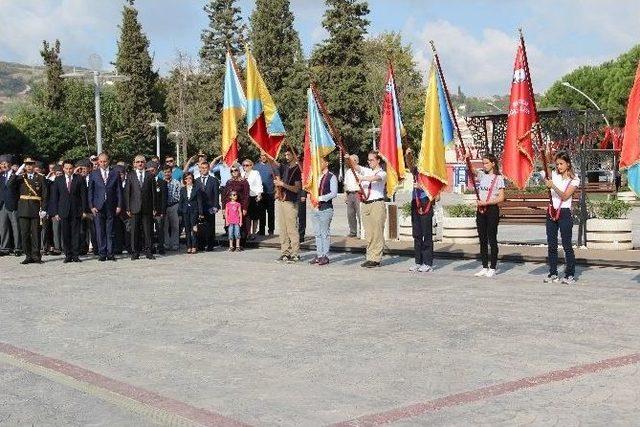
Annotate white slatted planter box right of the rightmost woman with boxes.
[587,218,633,250]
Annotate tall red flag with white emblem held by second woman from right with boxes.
[502,43,538,189]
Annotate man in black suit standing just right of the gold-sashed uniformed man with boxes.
[49,160,89,263]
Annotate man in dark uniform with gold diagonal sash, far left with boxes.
[13,157,48,264]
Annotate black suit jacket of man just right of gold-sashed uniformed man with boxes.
[49,174,89,218]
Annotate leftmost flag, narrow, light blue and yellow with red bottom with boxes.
[221,52,247,166]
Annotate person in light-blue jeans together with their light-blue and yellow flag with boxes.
[302,88,338,265]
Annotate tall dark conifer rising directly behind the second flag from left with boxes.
[249,0,309,146]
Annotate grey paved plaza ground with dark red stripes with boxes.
[0,249,640,426]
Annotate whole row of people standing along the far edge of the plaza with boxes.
[0,149,579,284]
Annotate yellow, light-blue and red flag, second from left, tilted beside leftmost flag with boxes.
[246,51,286,159]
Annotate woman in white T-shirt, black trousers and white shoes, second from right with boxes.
[475,153,504,277]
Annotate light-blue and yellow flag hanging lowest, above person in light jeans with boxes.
[302,88,336,206]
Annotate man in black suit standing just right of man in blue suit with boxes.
[124,155,157,260]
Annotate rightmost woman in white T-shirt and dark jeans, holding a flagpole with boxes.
[544,151,580,285]
